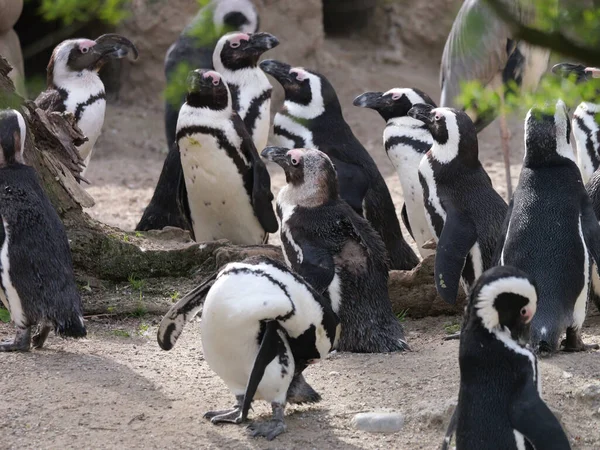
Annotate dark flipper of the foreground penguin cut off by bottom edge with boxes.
[509,384,571,450]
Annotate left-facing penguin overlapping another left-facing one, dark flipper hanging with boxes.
[408,104,507,303]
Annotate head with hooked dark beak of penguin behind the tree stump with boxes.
[46,34,138,86]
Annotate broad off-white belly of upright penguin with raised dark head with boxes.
[179,134,265,245]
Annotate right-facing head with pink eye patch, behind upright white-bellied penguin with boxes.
[213,32,279,72]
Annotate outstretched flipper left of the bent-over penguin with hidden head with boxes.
[156,271,219,350]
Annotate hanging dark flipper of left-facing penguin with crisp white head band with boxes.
[434,207,477,305]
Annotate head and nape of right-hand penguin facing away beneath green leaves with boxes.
[523,100,575,167]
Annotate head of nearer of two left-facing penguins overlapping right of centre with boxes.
[408,103,479,165]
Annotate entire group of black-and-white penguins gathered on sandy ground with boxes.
[0,0,600,449]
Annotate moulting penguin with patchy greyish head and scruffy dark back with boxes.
[261,147,409,353]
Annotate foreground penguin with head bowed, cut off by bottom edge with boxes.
[442,266,571,450]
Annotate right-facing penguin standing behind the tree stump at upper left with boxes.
[35,34,138,176]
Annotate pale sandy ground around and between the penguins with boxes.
[0,40,600,450]
